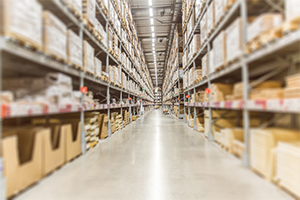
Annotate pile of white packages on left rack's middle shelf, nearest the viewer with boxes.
[1,73,81,105]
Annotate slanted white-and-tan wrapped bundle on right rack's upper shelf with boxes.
[247,13,282,42]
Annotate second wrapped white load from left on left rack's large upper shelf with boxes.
[43,11,67,61]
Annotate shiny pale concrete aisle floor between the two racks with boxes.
[15,110,293,200]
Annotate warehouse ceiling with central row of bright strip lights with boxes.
[128,0,182,87]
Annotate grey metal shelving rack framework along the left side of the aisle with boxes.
[0,0,154,199]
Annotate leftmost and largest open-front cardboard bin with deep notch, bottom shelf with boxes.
[1,127,45,198]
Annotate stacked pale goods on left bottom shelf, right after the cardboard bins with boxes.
[84,112,100,149]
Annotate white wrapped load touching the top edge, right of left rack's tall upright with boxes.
[82,0,97,28]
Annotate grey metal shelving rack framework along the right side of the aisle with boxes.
[178,0,300,167]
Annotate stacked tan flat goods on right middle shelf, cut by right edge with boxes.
[283,74,300,98]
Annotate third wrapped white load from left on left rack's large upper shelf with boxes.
[67,30,82,69]
